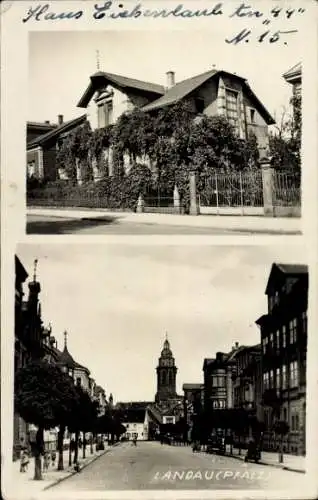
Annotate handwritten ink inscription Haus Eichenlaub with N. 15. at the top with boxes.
[22,1,305,45]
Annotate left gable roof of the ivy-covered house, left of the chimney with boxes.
[77,71,165,108]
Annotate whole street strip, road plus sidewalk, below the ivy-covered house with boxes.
[26,214,300,235]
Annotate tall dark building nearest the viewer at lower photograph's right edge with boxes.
[256,263,308,454]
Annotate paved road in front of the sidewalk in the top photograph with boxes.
[27,215,262,235]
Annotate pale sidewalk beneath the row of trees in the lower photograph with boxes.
[5,445,112,500]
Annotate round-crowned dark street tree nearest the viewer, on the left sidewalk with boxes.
[14,361,79,480]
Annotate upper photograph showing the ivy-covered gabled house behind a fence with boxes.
[26,27,302,235]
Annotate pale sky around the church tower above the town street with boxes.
[17,242,306,401]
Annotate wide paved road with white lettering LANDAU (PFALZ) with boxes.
[48,442,305,490]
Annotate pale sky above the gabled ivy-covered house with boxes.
[27,27,302,123]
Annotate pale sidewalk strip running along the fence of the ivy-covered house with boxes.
[27,207,302,235]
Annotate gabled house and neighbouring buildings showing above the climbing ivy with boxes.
[27,64,301,183]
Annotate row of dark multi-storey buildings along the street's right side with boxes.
[183,263,308,454]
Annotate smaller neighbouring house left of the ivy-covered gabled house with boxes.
[26,115,86,181]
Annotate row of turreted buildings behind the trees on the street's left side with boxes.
[13,255,112,458]
